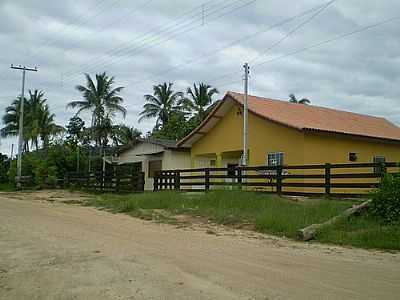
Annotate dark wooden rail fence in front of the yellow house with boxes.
[154,162,399,195]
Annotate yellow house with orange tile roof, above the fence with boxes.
[178,92,400,193]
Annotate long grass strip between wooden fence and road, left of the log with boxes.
[88,191,353,238]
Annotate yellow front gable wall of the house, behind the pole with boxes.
[191,105,304,167]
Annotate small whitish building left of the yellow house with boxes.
[114,138,191,191]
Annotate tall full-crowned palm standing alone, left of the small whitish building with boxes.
[67,72,126,145]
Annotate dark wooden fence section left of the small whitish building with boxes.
[64,172,144,193]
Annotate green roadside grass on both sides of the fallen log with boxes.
[88,191,400,250]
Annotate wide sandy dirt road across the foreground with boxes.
[0,194,400,300]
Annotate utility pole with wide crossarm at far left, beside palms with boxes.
[11,64,37,188]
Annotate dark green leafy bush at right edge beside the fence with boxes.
[370,174,400,223]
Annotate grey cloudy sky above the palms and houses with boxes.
[0,0,400,153]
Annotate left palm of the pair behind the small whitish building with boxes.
[139,82,183,127]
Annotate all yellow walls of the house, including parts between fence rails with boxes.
[191,105,400,193]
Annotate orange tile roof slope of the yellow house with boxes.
[227,92,400,140]
